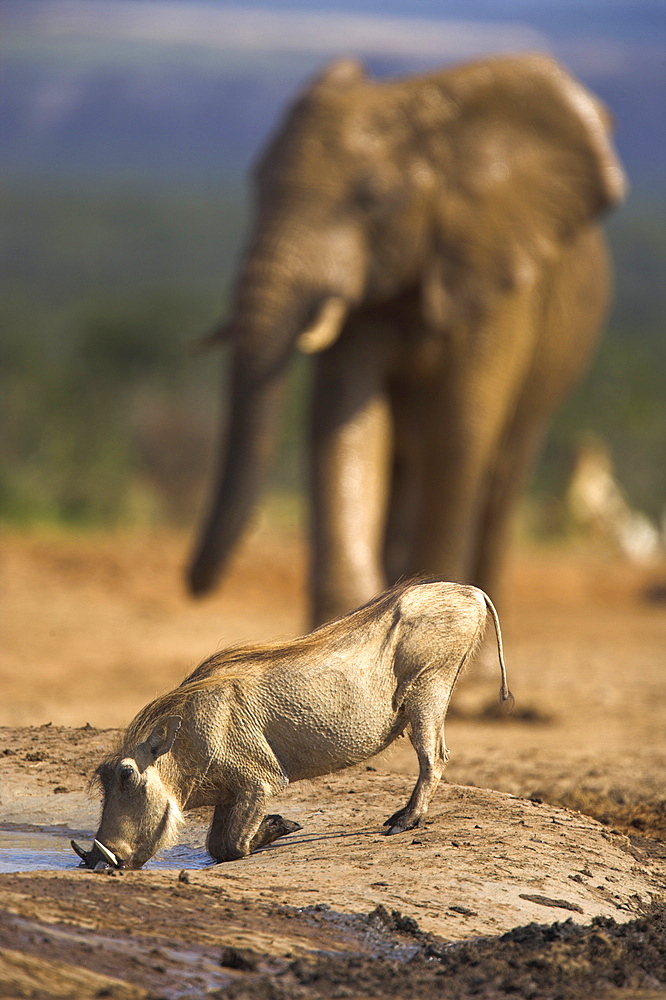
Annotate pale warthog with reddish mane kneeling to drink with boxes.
[72,581,513,868]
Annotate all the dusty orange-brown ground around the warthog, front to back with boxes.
[0,527,666,1000]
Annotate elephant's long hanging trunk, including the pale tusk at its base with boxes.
[188,219,363,594]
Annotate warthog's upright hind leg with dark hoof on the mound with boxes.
[384,674,451,835]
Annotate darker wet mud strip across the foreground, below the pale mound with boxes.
[0,873,666,1000]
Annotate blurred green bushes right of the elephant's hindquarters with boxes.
[533,206,666,522]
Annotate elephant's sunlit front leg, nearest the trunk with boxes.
[311,327,392,624]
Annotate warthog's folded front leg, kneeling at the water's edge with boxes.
[206,784,301,861]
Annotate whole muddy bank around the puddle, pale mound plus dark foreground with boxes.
[0,726,666,1000]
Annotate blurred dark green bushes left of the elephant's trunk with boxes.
[0,290,223,524]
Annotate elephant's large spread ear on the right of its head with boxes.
[414,56,625,327]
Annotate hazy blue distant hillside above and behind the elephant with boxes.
[0,0,666,190]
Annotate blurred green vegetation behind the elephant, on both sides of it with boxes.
[0,179,666,525]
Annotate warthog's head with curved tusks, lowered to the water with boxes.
[72,715,182,868]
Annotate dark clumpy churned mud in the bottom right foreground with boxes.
[223,905,666,1000]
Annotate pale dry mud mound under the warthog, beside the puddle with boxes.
[0,726,666,939]
